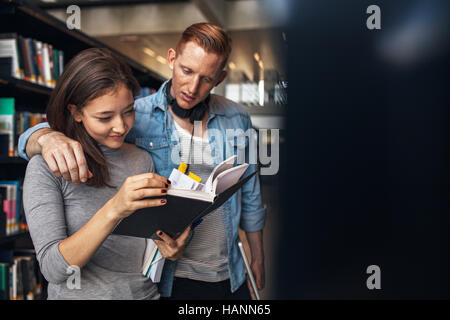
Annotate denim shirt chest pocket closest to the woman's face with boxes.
[136,136,170,173]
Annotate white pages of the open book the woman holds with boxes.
[167,155,248,202]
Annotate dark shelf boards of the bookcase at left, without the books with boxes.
[0,0,166,297]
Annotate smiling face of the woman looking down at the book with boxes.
[69,85,134,149]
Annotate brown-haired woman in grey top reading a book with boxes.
[23,48,187,299]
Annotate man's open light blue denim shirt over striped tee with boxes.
[18,81,266,297]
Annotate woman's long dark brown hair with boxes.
[47,48,140,187]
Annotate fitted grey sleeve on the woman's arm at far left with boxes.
[23,155,71,283]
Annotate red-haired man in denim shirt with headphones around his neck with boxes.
[19,23,266,299]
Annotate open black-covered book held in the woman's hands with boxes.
[113,156,256,239]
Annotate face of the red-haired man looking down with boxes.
[167,41,226,109]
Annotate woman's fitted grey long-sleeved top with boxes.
[23,144,159,300]
